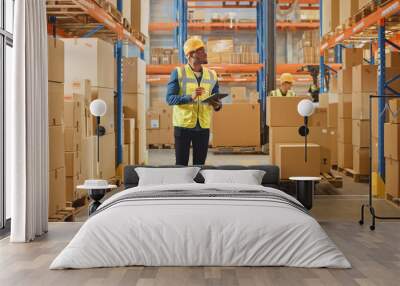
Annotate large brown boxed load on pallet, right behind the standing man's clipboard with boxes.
[211,86,261,153]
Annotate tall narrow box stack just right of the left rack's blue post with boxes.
[122,57,149,164]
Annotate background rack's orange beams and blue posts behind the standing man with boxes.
[147,0,326,145]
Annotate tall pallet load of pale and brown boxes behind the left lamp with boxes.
[64,38,116,203]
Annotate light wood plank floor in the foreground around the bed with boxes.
[0,222,400,286]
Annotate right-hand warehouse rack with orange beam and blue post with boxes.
[320,0,400,230]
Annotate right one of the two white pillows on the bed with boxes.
[200,170,265,185]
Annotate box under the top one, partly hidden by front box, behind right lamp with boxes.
[269,127,321,164]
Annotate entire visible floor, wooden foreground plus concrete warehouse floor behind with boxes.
[0,150,400,286]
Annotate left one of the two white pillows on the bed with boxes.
[135,167,200,186]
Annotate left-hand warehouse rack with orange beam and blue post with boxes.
[46,0,146,166]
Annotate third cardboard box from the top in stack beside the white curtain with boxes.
[49,126,65,171]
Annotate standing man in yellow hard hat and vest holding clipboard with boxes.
[167,38,222,166]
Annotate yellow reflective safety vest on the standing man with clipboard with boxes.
[173,65,217,128]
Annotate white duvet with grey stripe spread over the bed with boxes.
[50,184,351,269]
